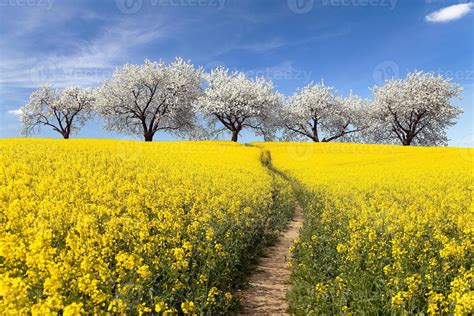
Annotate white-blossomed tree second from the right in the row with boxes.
[280,82,368,142]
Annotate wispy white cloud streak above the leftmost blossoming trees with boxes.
[0,17,170,88]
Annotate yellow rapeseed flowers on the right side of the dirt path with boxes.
[259,143,474,315]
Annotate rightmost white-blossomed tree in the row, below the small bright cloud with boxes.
[370,71,462,146]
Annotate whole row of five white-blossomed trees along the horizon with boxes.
[21,58,462,146]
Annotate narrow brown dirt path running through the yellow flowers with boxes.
[239,205,303,315]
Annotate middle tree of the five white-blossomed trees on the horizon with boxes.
[195,68,281,142]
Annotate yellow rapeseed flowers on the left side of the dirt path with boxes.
[0,139,293,315]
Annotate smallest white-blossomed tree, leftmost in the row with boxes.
[20,86,95,139]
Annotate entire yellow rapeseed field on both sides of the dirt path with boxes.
[0,139,474,315]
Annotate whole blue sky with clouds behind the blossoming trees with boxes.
[0,0,474,146]
